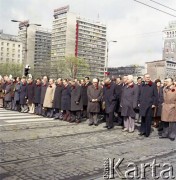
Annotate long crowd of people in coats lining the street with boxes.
[0,74,176,141]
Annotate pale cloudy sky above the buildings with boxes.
[0,0,176,67]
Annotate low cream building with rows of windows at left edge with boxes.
[0,31,22,64]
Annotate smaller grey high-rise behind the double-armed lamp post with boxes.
[19,21,51,76]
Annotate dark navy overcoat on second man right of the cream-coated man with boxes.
[61,85,71,110]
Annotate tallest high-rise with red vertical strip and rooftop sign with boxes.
[51,6,106,78]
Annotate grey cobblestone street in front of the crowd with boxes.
[0,110,176,180]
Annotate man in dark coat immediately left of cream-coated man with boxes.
[40,76,48,117]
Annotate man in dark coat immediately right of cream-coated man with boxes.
[53,78,63,119]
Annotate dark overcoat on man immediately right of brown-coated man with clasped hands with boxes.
[103,82,117,113]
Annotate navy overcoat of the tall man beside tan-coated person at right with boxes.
[138,82,158,117]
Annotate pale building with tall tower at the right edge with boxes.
[146,21,176,80]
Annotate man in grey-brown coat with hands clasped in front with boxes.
[87,79,103,126]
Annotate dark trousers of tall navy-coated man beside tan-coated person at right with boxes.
[140,116,152,137]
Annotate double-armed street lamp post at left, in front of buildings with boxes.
[11,19,41,74]
